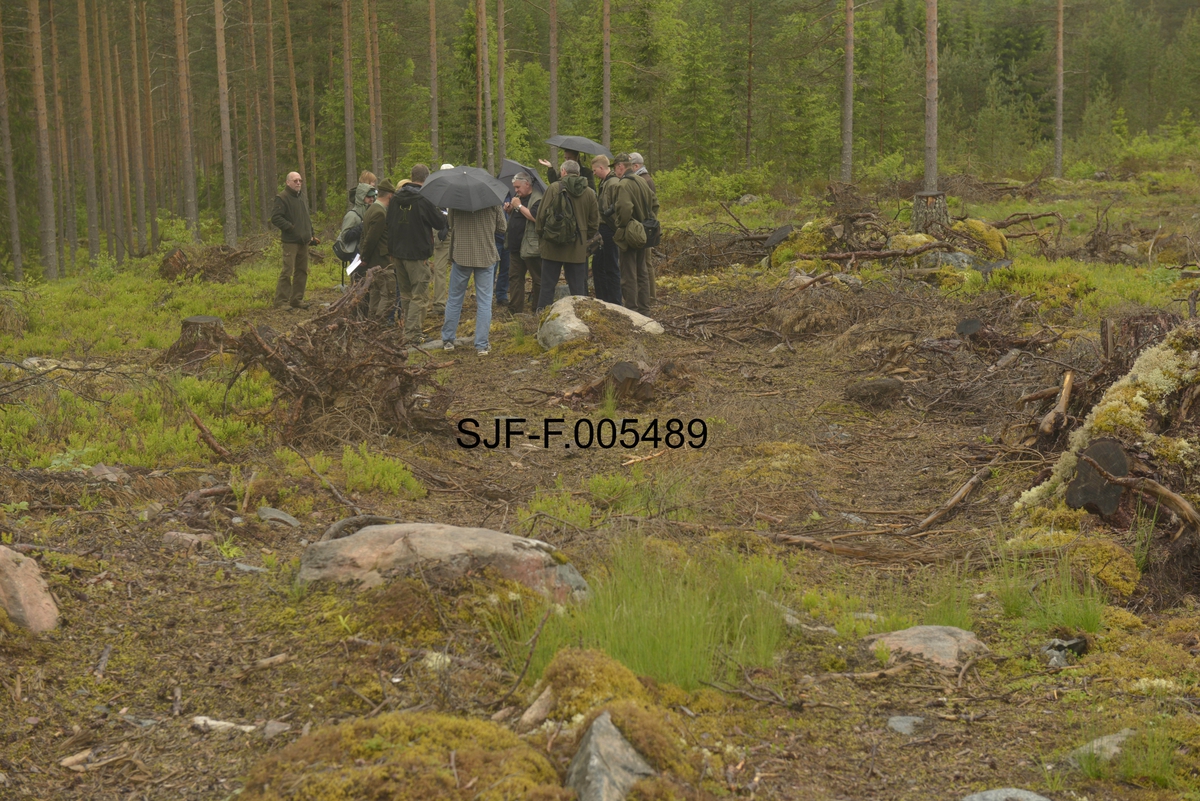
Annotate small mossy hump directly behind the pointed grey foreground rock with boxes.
[536,648,648,721]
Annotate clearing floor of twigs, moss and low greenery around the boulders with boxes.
[0,165,1200,801]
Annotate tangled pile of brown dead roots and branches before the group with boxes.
[234,267,450,444]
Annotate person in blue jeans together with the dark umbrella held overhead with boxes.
[421,167,509,356]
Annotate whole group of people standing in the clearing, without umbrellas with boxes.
[271,150,659,355]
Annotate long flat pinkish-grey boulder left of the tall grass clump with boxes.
[299,523,588,602]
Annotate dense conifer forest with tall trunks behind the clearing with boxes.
[0,0,1200,277]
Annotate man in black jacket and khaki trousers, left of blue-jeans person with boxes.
[388,164,446,344]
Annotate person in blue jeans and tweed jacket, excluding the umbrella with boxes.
[442,201,508,356]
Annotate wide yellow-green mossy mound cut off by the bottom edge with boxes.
[239,713,575,801]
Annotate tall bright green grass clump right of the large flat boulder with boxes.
[492,540,785,691]
